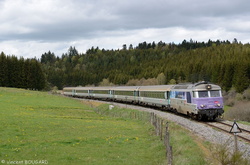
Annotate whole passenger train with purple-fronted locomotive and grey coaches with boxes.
[63,81,224,120]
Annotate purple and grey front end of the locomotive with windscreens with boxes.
[193,83,224,120]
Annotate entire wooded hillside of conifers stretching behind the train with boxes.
[0,39,250,92]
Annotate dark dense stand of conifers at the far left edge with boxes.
[0,52,46,90]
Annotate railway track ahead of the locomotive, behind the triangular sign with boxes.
[204,121,250,143]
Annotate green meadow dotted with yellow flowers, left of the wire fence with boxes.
[0,88,166,165]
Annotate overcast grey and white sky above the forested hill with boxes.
[0,0,250,58]
